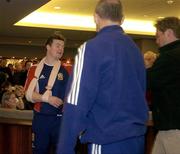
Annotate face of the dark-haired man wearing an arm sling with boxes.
[47,39,64,60]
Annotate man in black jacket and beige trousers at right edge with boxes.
[147,17,180,154]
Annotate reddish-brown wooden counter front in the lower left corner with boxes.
[0,123,32,154]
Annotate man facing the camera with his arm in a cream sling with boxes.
[25,35,68,154]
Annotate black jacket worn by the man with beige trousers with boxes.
[147,40,180,130]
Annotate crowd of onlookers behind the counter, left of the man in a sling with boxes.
[0,59,33,110]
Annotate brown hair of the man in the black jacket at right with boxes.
[155,17,180,38]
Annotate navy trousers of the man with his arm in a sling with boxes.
[32,114,62,154]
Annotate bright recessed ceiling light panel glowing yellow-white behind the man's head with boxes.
[15,11,155,35]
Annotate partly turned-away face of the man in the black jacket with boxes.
[156,30,168,47]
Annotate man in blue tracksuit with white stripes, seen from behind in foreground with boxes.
[57,0,148,154]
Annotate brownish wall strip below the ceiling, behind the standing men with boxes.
[0,38,158,58]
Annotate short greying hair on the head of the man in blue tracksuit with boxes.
[95,0,123,22]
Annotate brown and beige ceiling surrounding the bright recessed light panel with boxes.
[0,0,180,47]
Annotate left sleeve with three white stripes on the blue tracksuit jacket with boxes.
[57,44,98,154]
